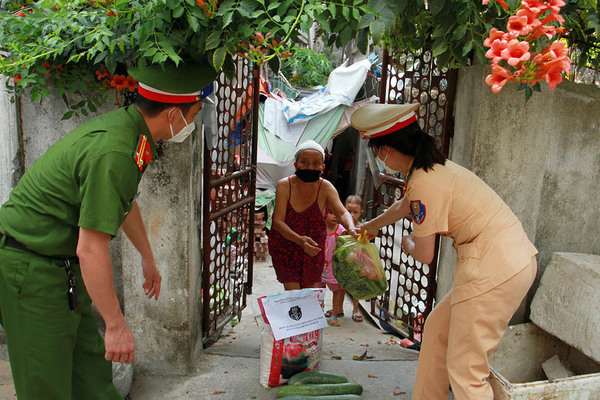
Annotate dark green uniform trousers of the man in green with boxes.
[0,243,123,400]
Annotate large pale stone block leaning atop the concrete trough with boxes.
[531,253,600,362]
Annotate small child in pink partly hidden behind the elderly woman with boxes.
[321,208,346,326]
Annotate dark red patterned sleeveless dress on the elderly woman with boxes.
[269,178,327,288]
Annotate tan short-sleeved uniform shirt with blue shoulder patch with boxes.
[406,160,537,304]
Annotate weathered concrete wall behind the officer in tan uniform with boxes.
[438,66,600,320]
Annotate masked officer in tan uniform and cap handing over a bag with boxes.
[351,104,537,400]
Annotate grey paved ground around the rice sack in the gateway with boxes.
[0,262,418,400]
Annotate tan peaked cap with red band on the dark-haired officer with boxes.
[350,103,421,139]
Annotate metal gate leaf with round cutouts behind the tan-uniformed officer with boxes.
[371,50,457,346]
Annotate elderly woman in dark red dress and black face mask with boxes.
[268,140,356,290]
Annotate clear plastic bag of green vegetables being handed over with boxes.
[333,235,387,300]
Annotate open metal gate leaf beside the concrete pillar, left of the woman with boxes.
[201,58,259,346]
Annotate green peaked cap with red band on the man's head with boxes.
[128,63,217,103]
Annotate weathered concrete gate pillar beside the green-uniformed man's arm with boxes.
[123,135,202,375]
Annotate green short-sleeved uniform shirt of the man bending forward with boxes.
[0,106,156,257]
